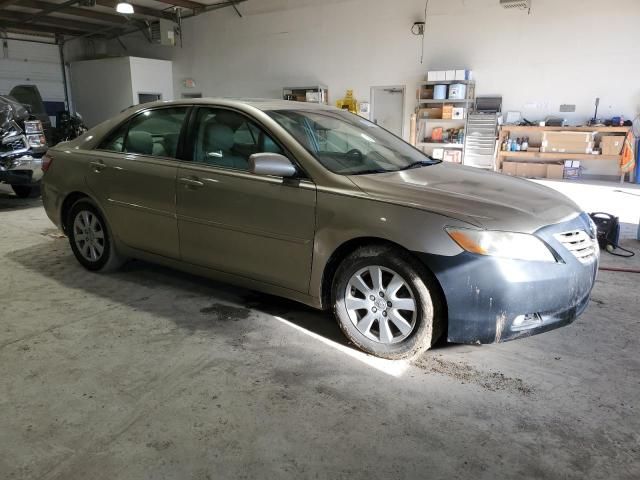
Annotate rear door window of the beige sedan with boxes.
[98,107,187,158]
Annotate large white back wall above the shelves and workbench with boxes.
[100,0,640,174]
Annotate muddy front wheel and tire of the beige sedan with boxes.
[332,246,443,359]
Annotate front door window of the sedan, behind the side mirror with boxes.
[192,108,283,170]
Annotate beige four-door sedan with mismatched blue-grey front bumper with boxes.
[43,99,599,358]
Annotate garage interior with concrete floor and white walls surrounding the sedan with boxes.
[0,0,640,480]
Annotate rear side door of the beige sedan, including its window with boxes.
[87,107,188,258]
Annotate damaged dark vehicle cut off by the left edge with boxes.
[0,96,47,198]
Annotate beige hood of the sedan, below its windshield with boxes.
[349,163,581,233]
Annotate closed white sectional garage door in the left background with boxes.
[0,40,64,116]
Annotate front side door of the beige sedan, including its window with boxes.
[177,108,316,293]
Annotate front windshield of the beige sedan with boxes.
[266,110,440,175]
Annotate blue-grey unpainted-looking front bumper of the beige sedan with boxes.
[417,214,599,343]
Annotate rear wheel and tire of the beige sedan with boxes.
[66,198,125,272]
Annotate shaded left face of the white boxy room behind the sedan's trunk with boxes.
[71,57,133,127]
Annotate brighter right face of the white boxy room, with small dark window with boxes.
[129,57,173,103]
